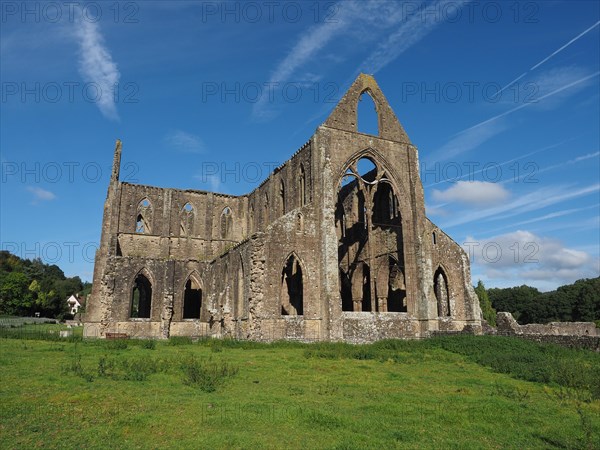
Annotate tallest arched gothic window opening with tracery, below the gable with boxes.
[335,156,408,312]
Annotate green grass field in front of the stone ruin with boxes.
[0,326,600,449]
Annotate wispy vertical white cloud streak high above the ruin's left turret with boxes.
[74,11,121,120]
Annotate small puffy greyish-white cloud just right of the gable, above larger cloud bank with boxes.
[433,181,510,207]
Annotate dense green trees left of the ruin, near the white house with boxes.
[0,250,91,319]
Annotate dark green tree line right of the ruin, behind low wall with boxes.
[487,277,600,325]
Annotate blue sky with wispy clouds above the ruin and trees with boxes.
[0,0,600,290]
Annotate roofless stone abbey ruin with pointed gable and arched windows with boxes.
[84,74,482,342]
